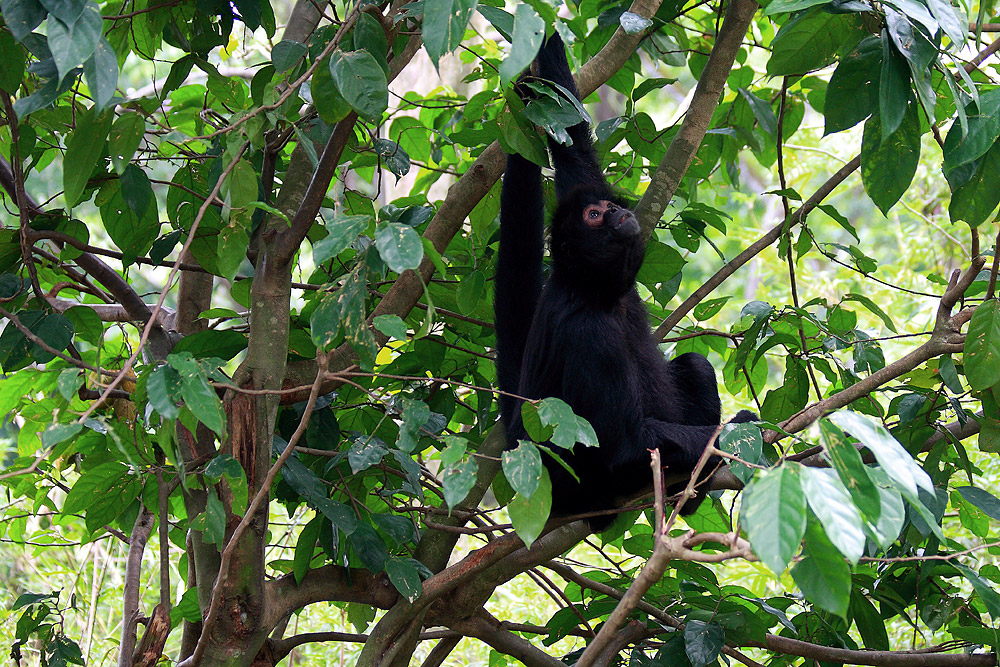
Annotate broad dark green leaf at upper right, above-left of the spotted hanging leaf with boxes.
[824,37,882,136]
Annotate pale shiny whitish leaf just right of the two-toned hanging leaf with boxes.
[802,467,865,563]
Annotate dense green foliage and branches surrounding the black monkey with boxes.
[0,0,1000,667]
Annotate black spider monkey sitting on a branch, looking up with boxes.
[494,33,757,530]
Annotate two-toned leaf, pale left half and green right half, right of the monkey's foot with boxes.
[740,463,806,574]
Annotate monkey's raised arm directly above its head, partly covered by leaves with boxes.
[536,32,608,199]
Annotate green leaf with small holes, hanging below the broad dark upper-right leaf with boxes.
[861,104,920,215]
